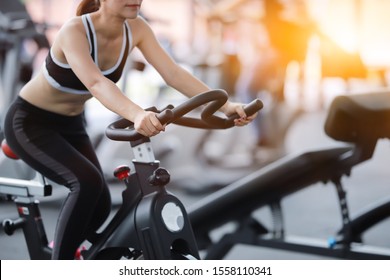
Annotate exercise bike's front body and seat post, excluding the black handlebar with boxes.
[0,138,200,259]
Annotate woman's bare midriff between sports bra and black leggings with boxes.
[20,73,92,116]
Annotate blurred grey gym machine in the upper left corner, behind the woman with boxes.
[0,0,50,119]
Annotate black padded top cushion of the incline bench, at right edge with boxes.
[325,92,390,143]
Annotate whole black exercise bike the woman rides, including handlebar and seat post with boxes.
[0,90,263,260]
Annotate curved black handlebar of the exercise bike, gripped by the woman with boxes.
[106,90,263,141]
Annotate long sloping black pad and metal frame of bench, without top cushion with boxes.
[188,143,390,259]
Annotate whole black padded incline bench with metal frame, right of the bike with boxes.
[188,93,390,260]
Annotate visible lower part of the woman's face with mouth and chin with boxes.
[100,0,143,19]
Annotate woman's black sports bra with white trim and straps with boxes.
[43,14,132,94]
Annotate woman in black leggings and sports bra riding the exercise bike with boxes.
[5,0,255,259]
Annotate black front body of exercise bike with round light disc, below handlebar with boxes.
[83,138,200,259]
